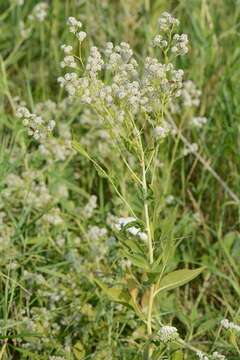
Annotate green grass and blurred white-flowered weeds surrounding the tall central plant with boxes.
[0,0,240,360]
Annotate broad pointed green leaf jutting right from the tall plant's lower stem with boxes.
[155,266,205,295]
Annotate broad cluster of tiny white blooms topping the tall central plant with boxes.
[58,16,186,119]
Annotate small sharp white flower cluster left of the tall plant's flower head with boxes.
[16,106,56,142]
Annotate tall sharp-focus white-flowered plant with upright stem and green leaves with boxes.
[58,13,206,359]
